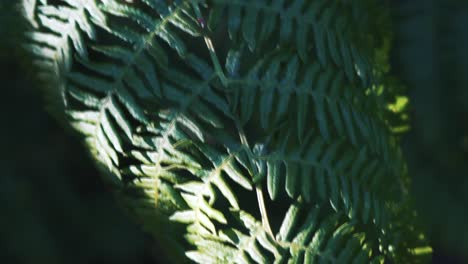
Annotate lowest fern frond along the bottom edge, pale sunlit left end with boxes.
[188,203,390,263]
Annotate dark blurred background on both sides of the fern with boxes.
[0,0,468,264]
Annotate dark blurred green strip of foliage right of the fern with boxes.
[392,0,468,263]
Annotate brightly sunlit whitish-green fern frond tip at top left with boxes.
[24,0,105,116]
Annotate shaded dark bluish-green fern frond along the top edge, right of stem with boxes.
[210,0,371,84]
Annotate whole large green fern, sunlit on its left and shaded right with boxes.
[25,0,427,263]
